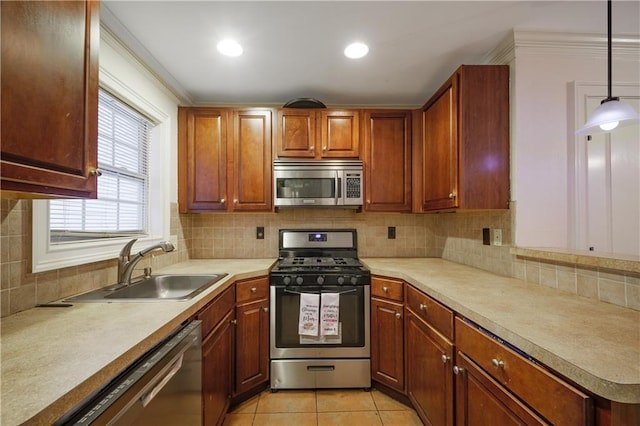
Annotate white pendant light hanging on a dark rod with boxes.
[576,0,640,135]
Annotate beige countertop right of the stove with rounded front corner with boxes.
[361,258,640,404]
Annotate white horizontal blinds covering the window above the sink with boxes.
[49,90,152,243]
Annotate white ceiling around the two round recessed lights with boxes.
[102,0,640,107]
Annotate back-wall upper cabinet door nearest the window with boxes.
[178,108,227,213]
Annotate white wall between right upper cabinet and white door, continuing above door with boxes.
[511,32,640,248]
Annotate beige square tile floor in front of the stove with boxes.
[224,389,422,426]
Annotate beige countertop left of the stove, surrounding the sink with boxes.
[0,259,275,426]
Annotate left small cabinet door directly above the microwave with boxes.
[277,109,316,158]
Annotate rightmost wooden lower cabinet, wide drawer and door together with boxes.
[454,318,595,426]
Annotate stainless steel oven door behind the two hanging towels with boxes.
[270,285,371,359]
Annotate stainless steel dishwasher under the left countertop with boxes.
[55,321,202,426]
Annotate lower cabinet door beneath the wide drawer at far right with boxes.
[455,352,549,426]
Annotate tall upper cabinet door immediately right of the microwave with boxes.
[363,111,411,212]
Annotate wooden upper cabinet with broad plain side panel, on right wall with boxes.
[418,65,509,211]
